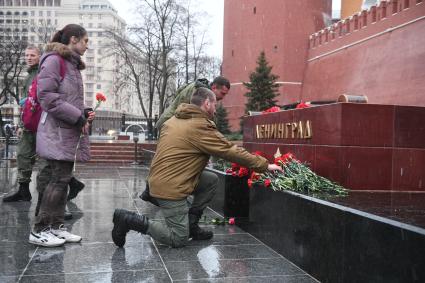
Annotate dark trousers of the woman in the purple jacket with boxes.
[34,160,74,232]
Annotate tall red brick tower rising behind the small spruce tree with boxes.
[222,0,332,130]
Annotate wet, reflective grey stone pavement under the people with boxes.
[0,163,317,283]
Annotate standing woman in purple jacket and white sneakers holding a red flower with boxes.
[29,24,94,247]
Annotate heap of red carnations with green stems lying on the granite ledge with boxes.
[248,153,347,195]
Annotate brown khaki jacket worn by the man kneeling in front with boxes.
[148,103,268,200]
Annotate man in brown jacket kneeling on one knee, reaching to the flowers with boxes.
[112,88,282,247]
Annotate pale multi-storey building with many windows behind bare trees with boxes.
[0,0,158,124]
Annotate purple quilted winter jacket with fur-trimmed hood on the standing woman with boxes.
[37,42,90,161]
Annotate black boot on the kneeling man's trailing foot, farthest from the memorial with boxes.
[112,209,149,247]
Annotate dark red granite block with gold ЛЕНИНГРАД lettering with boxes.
[244,103,425,191]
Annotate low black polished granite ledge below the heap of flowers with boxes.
[238,188,425,282]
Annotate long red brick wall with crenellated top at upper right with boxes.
[302,0,425,106]
